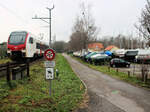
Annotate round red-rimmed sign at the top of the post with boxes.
[44,49,55,61]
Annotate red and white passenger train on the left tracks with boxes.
[7,31,49,61]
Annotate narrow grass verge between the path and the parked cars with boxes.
[72,56,150,88]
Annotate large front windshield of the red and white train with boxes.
[9,32,27,45]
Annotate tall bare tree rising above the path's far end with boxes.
[70,3,99,50]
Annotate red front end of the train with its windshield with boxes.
[7,31,28,60]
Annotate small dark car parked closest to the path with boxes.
[110,58,130,67]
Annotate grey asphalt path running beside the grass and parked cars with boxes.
[63,54,150,112]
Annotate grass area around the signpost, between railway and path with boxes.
[0,54,85,112]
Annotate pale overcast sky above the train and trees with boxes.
[0,0,146,42]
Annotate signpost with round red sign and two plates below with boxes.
[44,49,55,96]
